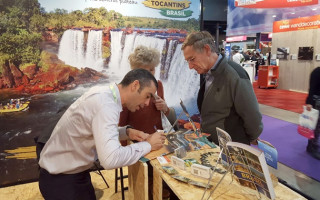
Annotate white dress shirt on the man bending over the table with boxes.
[39,84,151,174]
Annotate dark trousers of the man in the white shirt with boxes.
[39,168,96,200]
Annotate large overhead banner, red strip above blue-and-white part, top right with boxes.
[227,0,320,36]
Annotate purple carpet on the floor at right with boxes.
[260,115,320,181]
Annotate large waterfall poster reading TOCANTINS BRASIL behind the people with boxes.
[0,0,200,186]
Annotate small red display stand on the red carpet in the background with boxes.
[258,65,279,88]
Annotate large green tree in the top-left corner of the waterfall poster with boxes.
[0,0,44,66]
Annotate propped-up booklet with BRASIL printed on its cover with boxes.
[226,142,275,199]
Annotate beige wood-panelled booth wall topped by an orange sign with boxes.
[271,15,320,92]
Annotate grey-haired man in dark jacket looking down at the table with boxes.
[182,31,263,144]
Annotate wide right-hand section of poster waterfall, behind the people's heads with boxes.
[109,31,200,115]
